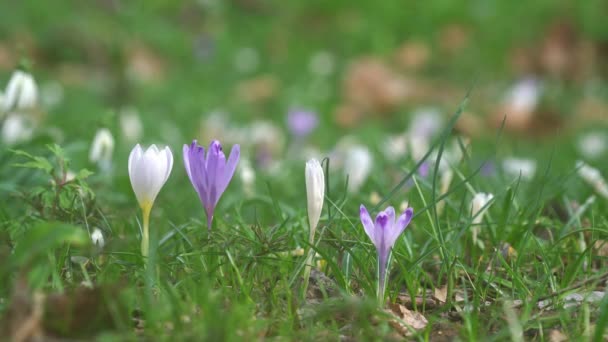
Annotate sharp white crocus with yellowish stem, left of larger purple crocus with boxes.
[129,144,173,256]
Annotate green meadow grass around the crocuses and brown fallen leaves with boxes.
[0,1,608,341]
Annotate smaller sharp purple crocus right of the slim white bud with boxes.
[359,204,414,302]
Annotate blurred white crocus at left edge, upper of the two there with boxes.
[2,70,38,112]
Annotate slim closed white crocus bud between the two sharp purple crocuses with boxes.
[305,159,325,236]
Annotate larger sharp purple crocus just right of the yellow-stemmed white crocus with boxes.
[184,140,241,230]
